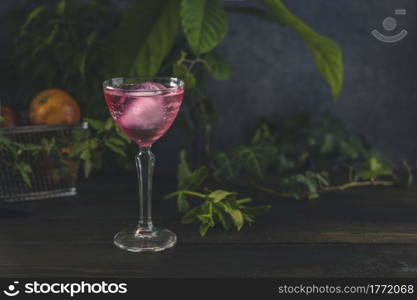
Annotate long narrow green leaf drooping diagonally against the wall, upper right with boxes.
[258,0,343,98]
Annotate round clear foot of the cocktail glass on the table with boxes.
[113,227,177,252]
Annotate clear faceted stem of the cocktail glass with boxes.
[136,146,155,232]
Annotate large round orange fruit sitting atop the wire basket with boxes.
[29,89,81,125]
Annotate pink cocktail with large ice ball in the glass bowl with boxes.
[104,82,184,147]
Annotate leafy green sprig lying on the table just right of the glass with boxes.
[165,150,270,236]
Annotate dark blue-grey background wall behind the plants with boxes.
[0,0,417,170]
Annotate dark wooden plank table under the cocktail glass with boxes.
[0,178,417,278]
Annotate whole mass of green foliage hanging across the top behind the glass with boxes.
[1,0,343,162]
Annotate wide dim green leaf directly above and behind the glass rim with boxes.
[109,0,179,76]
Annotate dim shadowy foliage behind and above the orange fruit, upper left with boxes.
[6,0,117,118]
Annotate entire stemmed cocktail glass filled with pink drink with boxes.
[103,77,184,252]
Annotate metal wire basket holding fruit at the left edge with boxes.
[0,123,88,202]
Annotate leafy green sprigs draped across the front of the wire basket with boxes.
[0,118,131,186]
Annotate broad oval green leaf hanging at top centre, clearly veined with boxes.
[181,0,227,55]
